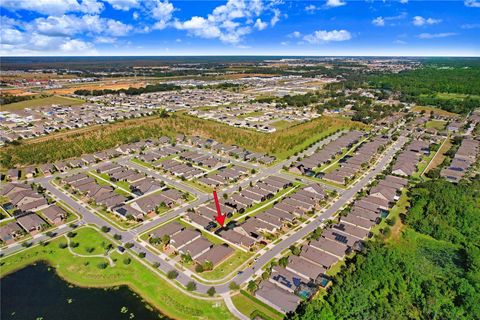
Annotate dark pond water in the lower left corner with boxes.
[0,263,168,320]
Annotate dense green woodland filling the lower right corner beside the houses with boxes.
[289,180,480,320]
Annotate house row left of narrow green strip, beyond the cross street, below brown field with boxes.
[289,131,364,174]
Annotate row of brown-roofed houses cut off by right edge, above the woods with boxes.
[440,138,480,182]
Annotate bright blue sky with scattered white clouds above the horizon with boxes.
[0,0,480,56]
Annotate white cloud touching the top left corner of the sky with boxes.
[1,0,104,15]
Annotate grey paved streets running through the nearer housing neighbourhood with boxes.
[2,133,406,300]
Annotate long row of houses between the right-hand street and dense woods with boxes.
[255,175,407,313]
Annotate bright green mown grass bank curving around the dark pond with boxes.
[0,228,234,320]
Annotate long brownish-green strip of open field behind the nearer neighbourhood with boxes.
[0,114,360,167]
